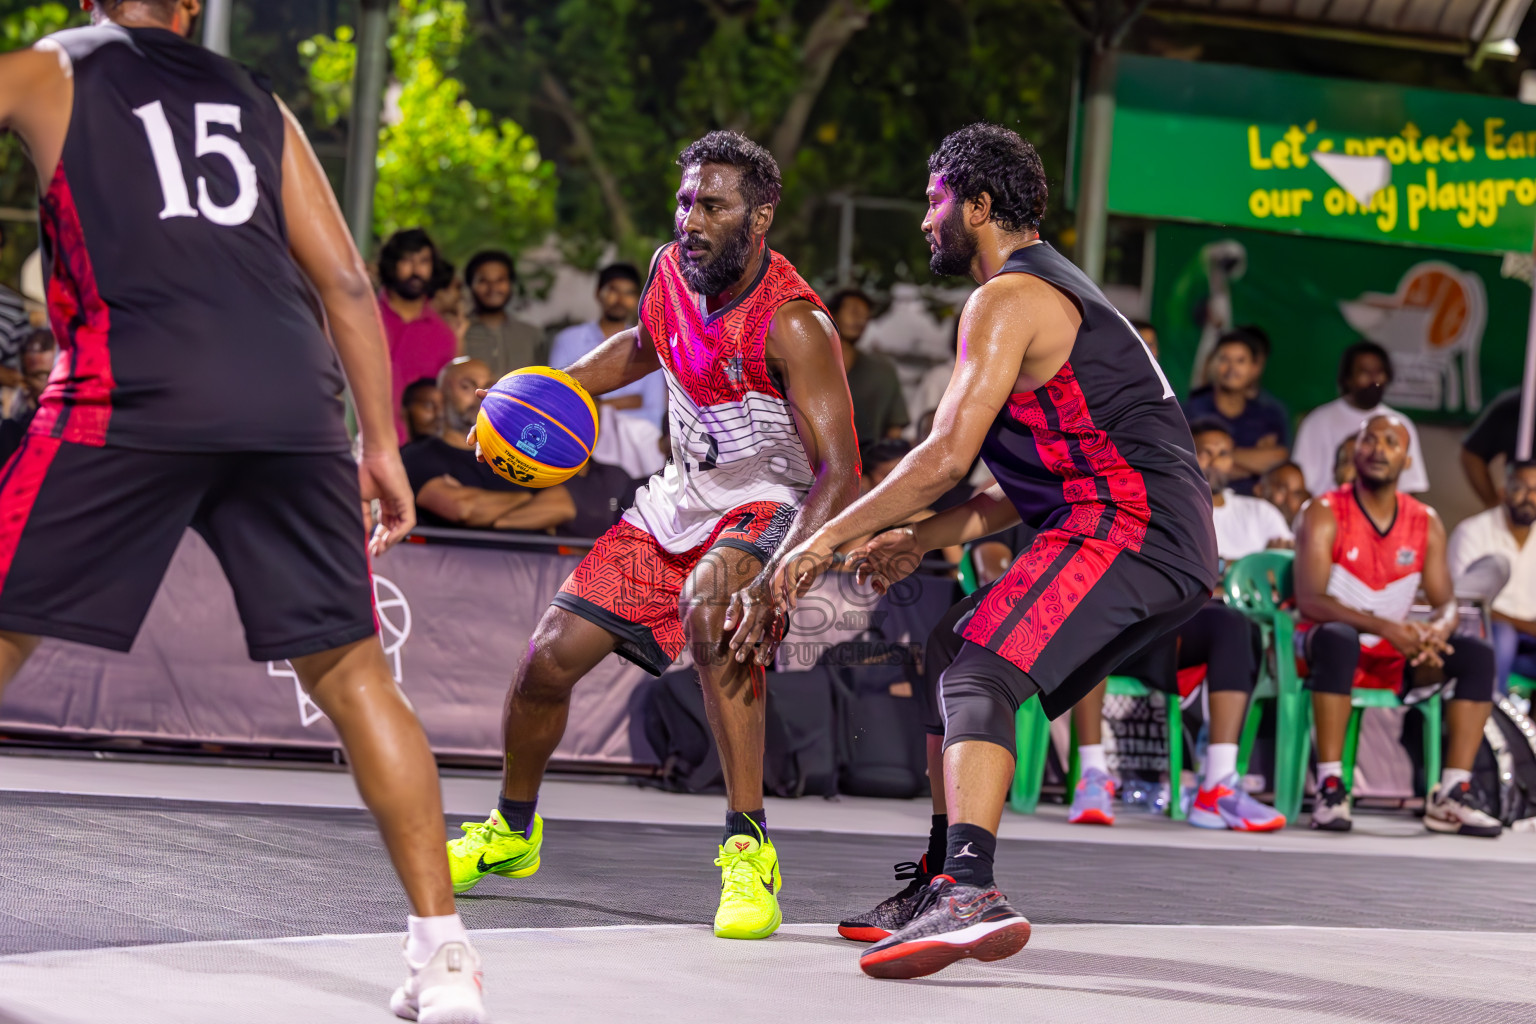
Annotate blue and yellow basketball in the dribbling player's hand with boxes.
[475,367,598,487]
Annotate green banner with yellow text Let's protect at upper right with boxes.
[1109,55,1536,252]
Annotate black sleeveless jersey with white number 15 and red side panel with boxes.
[31,25,347,451]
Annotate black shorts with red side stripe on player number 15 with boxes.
[0,434,376,662]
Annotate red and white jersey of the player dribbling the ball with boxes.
[624,243,826,554]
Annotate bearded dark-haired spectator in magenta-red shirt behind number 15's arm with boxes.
[379,227,459,444]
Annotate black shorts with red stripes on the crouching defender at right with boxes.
[952,530,1210,718]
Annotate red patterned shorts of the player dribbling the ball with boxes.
[553,502,797,676]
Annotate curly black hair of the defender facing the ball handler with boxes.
[928,121,1049,232]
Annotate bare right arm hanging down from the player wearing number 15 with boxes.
[280,101,416,554]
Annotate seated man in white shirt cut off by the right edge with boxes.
[1448,459,1536,692]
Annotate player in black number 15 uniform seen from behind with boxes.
[0,0,484,1024]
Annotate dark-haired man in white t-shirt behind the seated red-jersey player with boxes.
[1290,341,1430,494]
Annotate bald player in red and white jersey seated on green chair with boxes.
[1296,413,1501,835]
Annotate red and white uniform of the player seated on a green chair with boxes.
[1318,487,1430,688]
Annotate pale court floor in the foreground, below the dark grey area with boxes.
[0,924,1536,1024]
